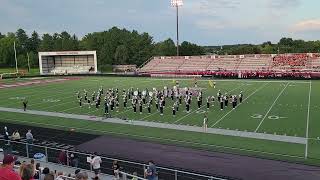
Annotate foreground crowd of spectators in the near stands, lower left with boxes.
[0,127,156,180]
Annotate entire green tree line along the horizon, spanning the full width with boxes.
[0,27,320,70]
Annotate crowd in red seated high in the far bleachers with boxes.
[273,54,308,67]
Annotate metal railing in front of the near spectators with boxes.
[0,139,228,180]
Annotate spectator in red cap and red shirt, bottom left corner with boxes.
[0,154,21,180]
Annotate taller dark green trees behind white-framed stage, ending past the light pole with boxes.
[0,27,205,69]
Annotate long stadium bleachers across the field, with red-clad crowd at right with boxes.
[139,53,320,74]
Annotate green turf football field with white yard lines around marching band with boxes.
[0,77,320,165]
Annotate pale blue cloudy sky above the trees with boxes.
[0,0,320,45]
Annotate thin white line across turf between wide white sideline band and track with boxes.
[0,115,304,159]
